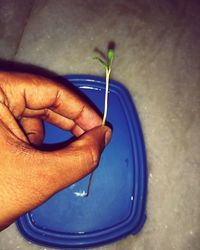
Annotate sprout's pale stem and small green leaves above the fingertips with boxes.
[94,49,114,126]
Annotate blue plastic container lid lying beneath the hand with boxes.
[17,75,147,248]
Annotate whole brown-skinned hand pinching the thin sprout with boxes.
[0,72,111,230]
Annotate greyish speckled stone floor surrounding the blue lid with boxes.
[0,0,200,250]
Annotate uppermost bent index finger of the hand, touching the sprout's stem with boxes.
[0,73,101,134]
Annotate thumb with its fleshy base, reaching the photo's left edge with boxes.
[0,126,112,230]
